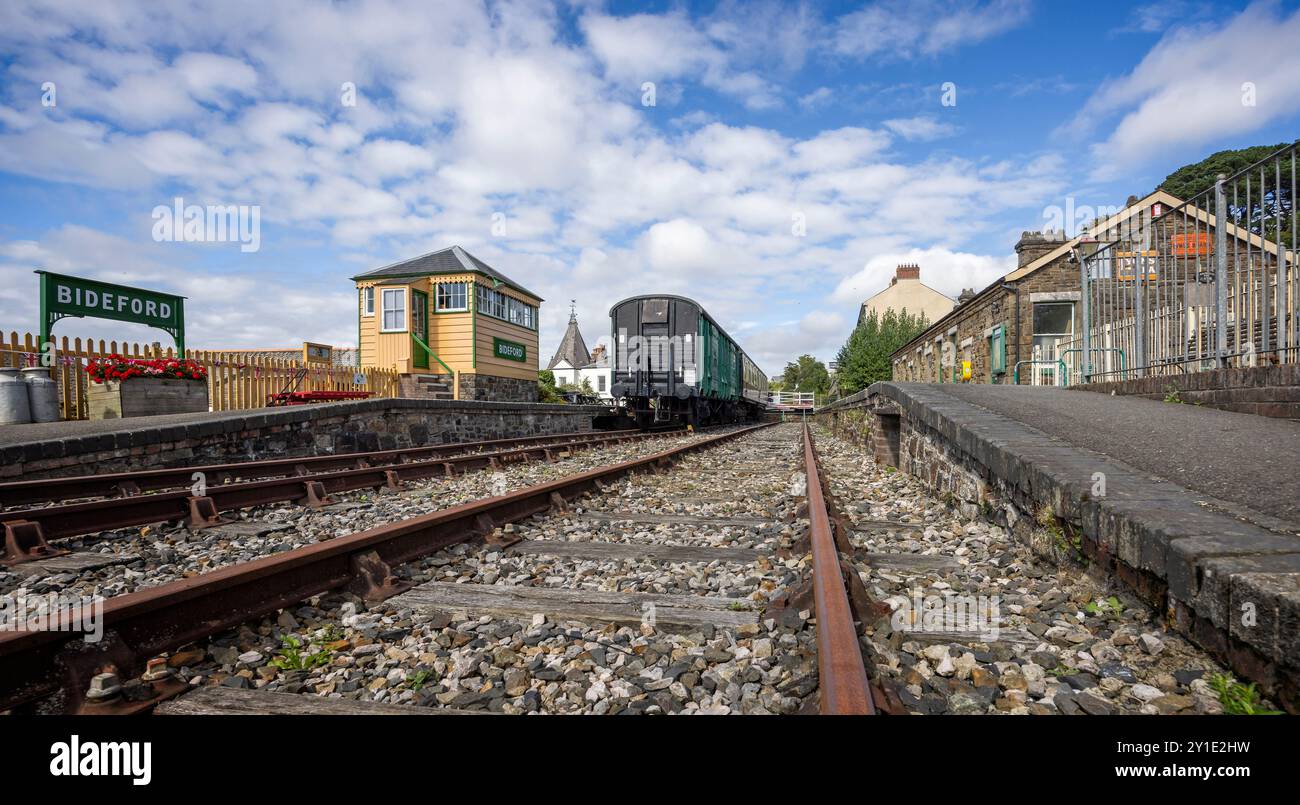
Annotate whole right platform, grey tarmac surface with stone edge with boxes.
[818,382,1300,710]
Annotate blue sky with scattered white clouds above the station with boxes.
[0,0,1300,375]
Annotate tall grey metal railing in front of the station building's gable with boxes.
[1070,142,1300,382]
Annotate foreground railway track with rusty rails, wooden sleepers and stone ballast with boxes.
[0,425,872,713]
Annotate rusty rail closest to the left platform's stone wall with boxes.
[0,429,640,508]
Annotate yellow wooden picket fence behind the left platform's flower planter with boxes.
[0,330,398,419]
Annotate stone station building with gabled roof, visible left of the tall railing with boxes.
[891,190,1182,384]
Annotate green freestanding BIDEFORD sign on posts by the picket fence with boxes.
[36,271,185,358]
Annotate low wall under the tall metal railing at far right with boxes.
[1071,364,1300,420]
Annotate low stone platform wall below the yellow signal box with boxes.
[0,399,606,480]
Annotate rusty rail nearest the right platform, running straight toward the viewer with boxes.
[803,423,875,715]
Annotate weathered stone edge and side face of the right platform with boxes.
[819,382,1300,713]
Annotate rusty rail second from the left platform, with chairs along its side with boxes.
[0,432,673,564]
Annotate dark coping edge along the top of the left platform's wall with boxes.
[0,398,607,466]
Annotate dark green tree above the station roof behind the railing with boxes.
[1160,143,1296,247]
